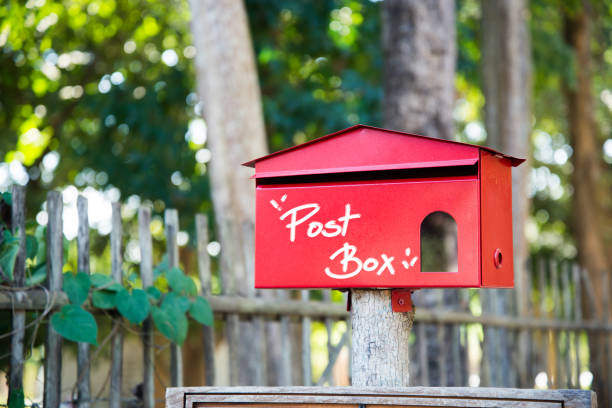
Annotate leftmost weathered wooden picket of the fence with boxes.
[8,185,26,404]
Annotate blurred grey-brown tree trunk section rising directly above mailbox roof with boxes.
[382,0,456,139]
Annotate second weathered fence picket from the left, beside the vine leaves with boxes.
[43,191,64,407]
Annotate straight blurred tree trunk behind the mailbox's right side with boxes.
[480,0,531,387]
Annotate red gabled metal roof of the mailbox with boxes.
[243,125,525,178]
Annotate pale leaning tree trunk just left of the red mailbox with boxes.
[190,0,266,385]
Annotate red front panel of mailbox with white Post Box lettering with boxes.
[255,176,480,288]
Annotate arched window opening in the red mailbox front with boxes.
[420,211,459,272]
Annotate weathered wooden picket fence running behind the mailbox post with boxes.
[0,187,612,407]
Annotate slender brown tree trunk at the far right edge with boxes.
[565,1,612,406]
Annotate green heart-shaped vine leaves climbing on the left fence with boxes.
[0,193,213,345]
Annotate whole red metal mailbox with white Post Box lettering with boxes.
[244,125,524,288]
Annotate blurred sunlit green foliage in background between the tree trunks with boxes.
[0,0,612,262]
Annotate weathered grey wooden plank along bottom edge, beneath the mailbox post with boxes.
[166,387,597,408]
